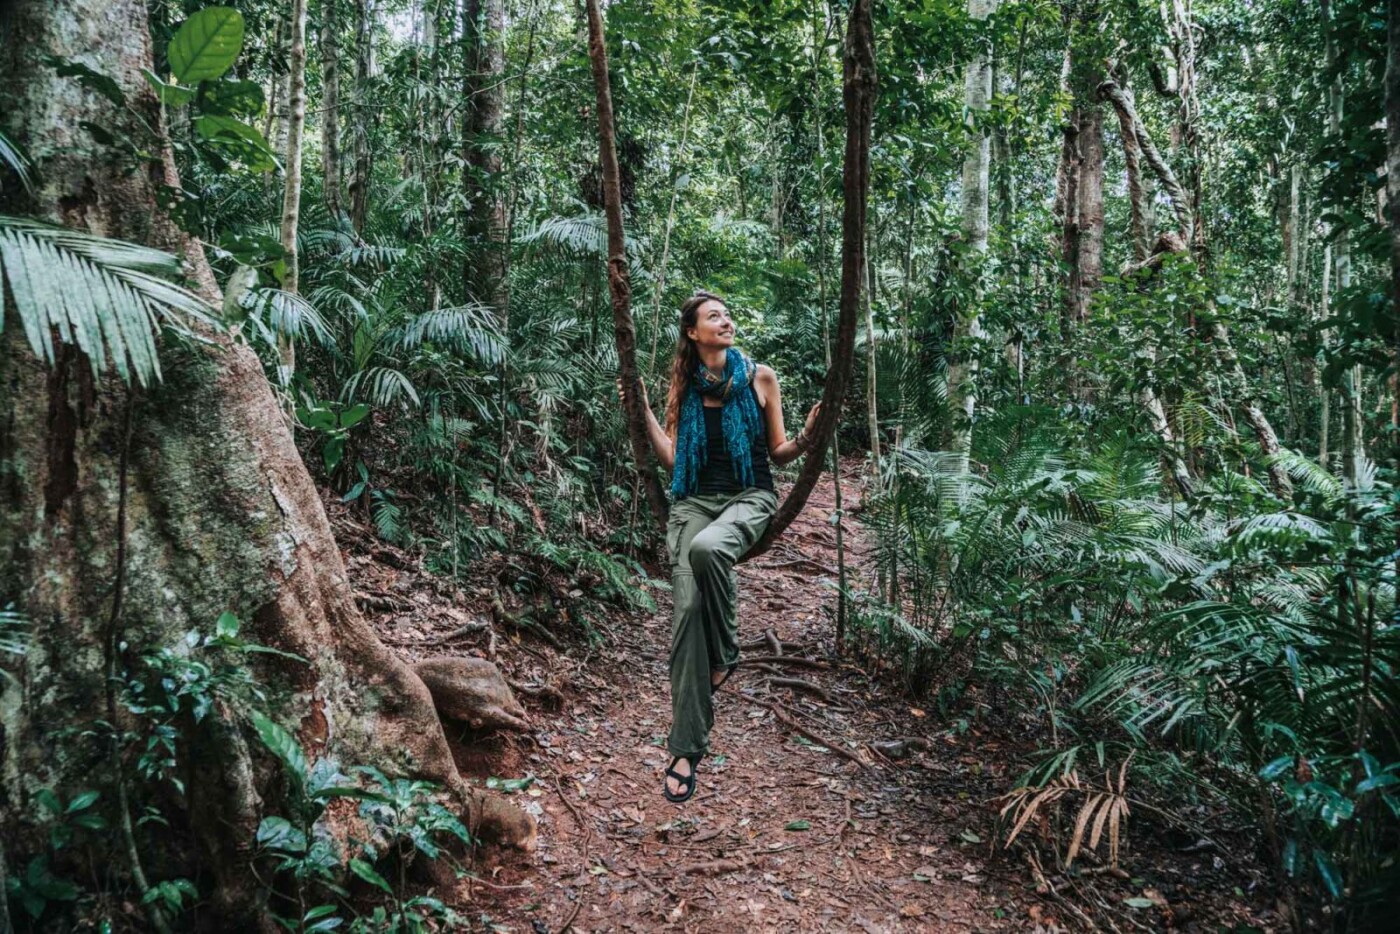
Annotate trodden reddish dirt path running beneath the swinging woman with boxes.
[463,475,1026,931]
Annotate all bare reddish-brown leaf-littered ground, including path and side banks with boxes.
[350,463,1278,934]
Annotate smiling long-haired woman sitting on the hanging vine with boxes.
[621,291,820,802]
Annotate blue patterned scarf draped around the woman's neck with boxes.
[671,347,763,500]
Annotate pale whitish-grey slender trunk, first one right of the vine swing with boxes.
[948,0,997,471]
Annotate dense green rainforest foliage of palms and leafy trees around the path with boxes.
[0,0,1400,930]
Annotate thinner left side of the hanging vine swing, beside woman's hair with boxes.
[587,0,666,525]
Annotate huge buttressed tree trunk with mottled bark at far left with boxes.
[0,0,531,930]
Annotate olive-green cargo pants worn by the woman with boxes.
[666,487,778,763]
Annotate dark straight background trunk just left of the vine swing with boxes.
[462,0,508,309]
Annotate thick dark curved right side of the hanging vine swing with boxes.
[750,0,875,560]
